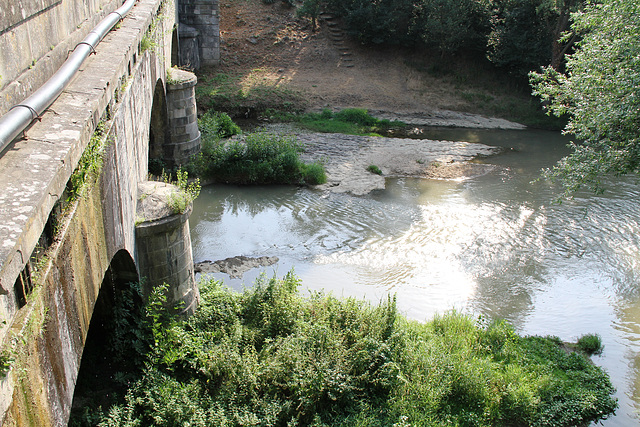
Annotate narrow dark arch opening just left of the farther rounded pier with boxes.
[148,79,170,176]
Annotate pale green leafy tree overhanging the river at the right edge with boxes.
[530,0,640,196]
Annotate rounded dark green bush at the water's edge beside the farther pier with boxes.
[194,132,326,185]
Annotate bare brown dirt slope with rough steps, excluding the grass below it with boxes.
[216,0,524,127]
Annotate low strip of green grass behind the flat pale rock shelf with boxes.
[265,108,406,136]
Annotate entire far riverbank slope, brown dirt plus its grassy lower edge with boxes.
[197,0,556,128]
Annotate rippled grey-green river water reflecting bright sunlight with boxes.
[190,129,640,426]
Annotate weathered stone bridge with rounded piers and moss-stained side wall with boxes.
[0,0,218,426]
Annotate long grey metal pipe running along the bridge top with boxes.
[0,0,136,154]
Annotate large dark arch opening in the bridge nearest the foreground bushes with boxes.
[69,250,142,425]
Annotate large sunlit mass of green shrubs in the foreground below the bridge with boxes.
[89,273,617,426]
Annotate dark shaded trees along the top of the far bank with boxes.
[324,0,564,68]
